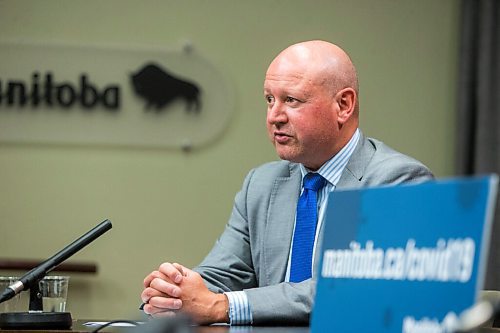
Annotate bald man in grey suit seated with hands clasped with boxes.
[141,40,433,325]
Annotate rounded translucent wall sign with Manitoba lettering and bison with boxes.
[0,43,234,149]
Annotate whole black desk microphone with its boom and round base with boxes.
[0,220,112,330]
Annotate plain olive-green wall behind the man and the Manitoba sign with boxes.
[0,0,459,319]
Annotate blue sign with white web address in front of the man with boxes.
[311,176,498,333]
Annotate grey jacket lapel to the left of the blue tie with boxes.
[263,164,302,284]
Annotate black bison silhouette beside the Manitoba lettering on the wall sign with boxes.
[131,64,201,113]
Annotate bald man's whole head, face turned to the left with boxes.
[264,40,358,170]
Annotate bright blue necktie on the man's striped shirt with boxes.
[290,173,326,282]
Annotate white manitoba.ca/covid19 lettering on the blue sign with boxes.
[321,238,475,283]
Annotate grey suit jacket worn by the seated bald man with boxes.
[195,135,433,325]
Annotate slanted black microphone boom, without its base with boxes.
[0,220,113,303]
